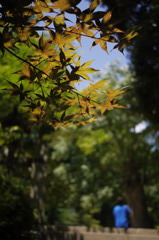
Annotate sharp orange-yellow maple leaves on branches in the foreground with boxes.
[0,0,138,128]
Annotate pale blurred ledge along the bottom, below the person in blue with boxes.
[37,226,159,240]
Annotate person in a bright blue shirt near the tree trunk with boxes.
[113,198,131,229]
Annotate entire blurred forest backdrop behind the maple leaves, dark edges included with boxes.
[0,0,159,239]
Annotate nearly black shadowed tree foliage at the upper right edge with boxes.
[98,0,159,124]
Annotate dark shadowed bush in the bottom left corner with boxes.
[0,166,34,240]
